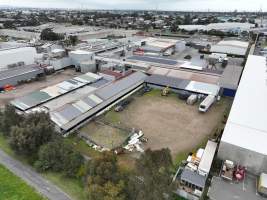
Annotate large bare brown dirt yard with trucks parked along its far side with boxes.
[95,91,231,155]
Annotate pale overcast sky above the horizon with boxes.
[0,0,267,11]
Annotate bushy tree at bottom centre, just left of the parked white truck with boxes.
[129,149,174,200]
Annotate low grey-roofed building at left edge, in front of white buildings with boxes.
[0,65,44,88]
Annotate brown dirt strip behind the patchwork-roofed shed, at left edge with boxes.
[0,69,80,108]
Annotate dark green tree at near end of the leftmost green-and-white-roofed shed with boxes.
[10,113,56,156]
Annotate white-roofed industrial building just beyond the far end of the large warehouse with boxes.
[210,40,249,57]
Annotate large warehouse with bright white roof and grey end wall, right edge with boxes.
[218,55,267,174]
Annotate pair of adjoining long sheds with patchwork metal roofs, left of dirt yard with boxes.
[11,72,147,134]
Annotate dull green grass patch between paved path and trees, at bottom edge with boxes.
[43,172,86,200]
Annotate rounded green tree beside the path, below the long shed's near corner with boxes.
[35,138,84,177]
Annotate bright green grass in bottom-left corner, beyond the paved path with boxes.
[0,165,45,200]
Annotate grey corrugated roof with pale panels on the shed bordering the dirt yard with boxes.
[51,72,146,130]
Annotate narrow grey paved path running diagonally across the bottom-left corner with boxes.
[0,150,71,200]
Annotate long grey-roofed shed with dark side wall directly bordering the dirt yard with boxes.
[50,72,146,134]
